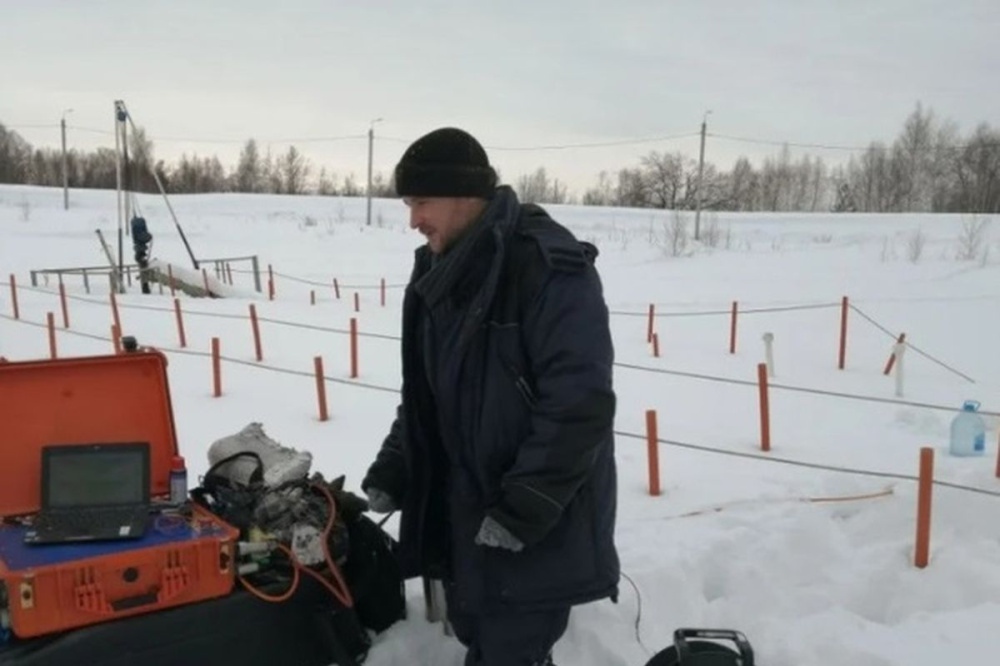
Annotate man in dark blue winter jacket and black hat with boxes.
[362,128,619,666]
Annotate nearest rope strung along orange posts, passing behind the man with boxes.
[0,313,1000,497]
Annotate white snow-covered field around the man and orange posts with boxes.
[0,186,1000,666]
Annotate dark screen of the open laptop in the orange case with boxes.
[42,444,149,509]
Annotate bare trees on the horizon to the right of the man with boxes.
[572,103,1000,213]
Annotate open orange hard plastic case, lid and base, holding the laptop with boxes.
[0,351,239,638]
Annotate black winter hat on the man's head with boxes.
[396,127,497,199]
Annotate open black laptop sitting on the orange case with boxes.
[24,442,150,545]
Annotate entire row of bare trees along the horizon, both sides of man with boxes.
[0,103,1000,213]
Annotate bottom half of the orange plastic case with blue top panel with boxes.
[0,507,239,638]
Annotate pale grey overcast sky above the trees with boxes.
[0,0,1000,193]
